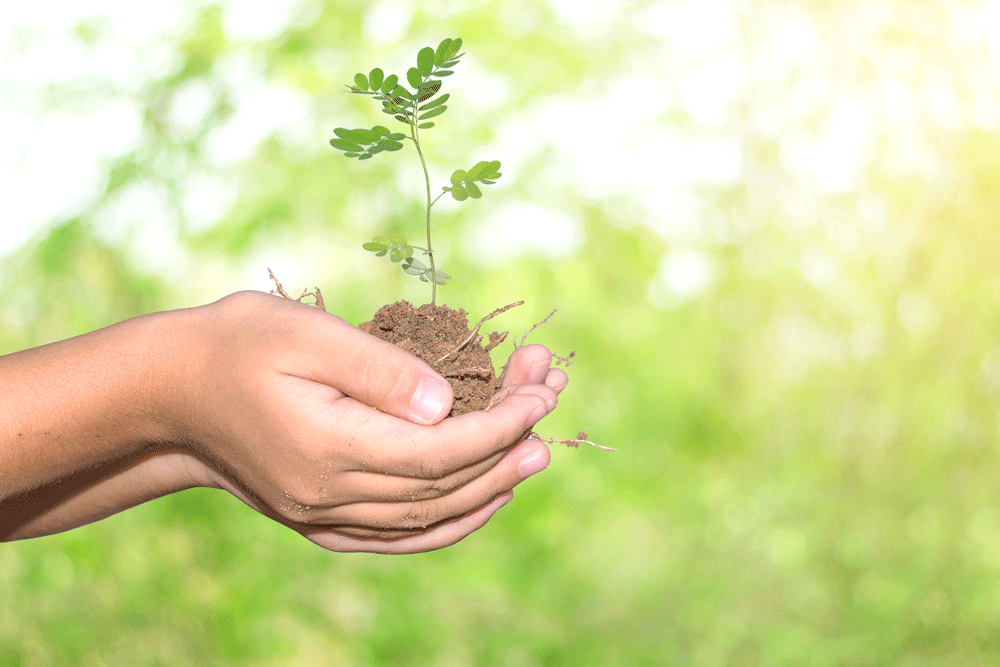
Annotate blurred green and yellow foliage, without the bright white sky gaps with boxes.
[0,0,1000,667]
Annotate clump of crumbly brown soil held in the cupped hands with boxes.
[358,301,507,417]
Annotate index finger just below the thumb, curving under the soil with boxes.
[329,385,558,480]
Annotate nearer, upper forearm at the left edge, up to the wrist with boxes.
[0,314,182,503]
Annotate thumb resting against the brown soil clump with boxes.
[281,298,453,424]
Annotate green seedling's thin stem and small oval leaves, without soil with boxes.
[330,39,501,305]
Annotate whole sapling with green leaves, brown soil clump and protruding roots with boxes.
[271,39,611,449]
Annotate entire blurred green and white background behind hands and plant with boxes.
[0,0,1000,667]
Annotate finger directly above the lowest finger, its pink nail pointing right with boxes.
[310,440,551,538]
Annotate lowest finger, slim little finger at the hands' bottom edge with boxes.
[305,492,514,554]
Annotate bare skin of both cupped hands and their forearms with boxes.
[0,292,568,553]
